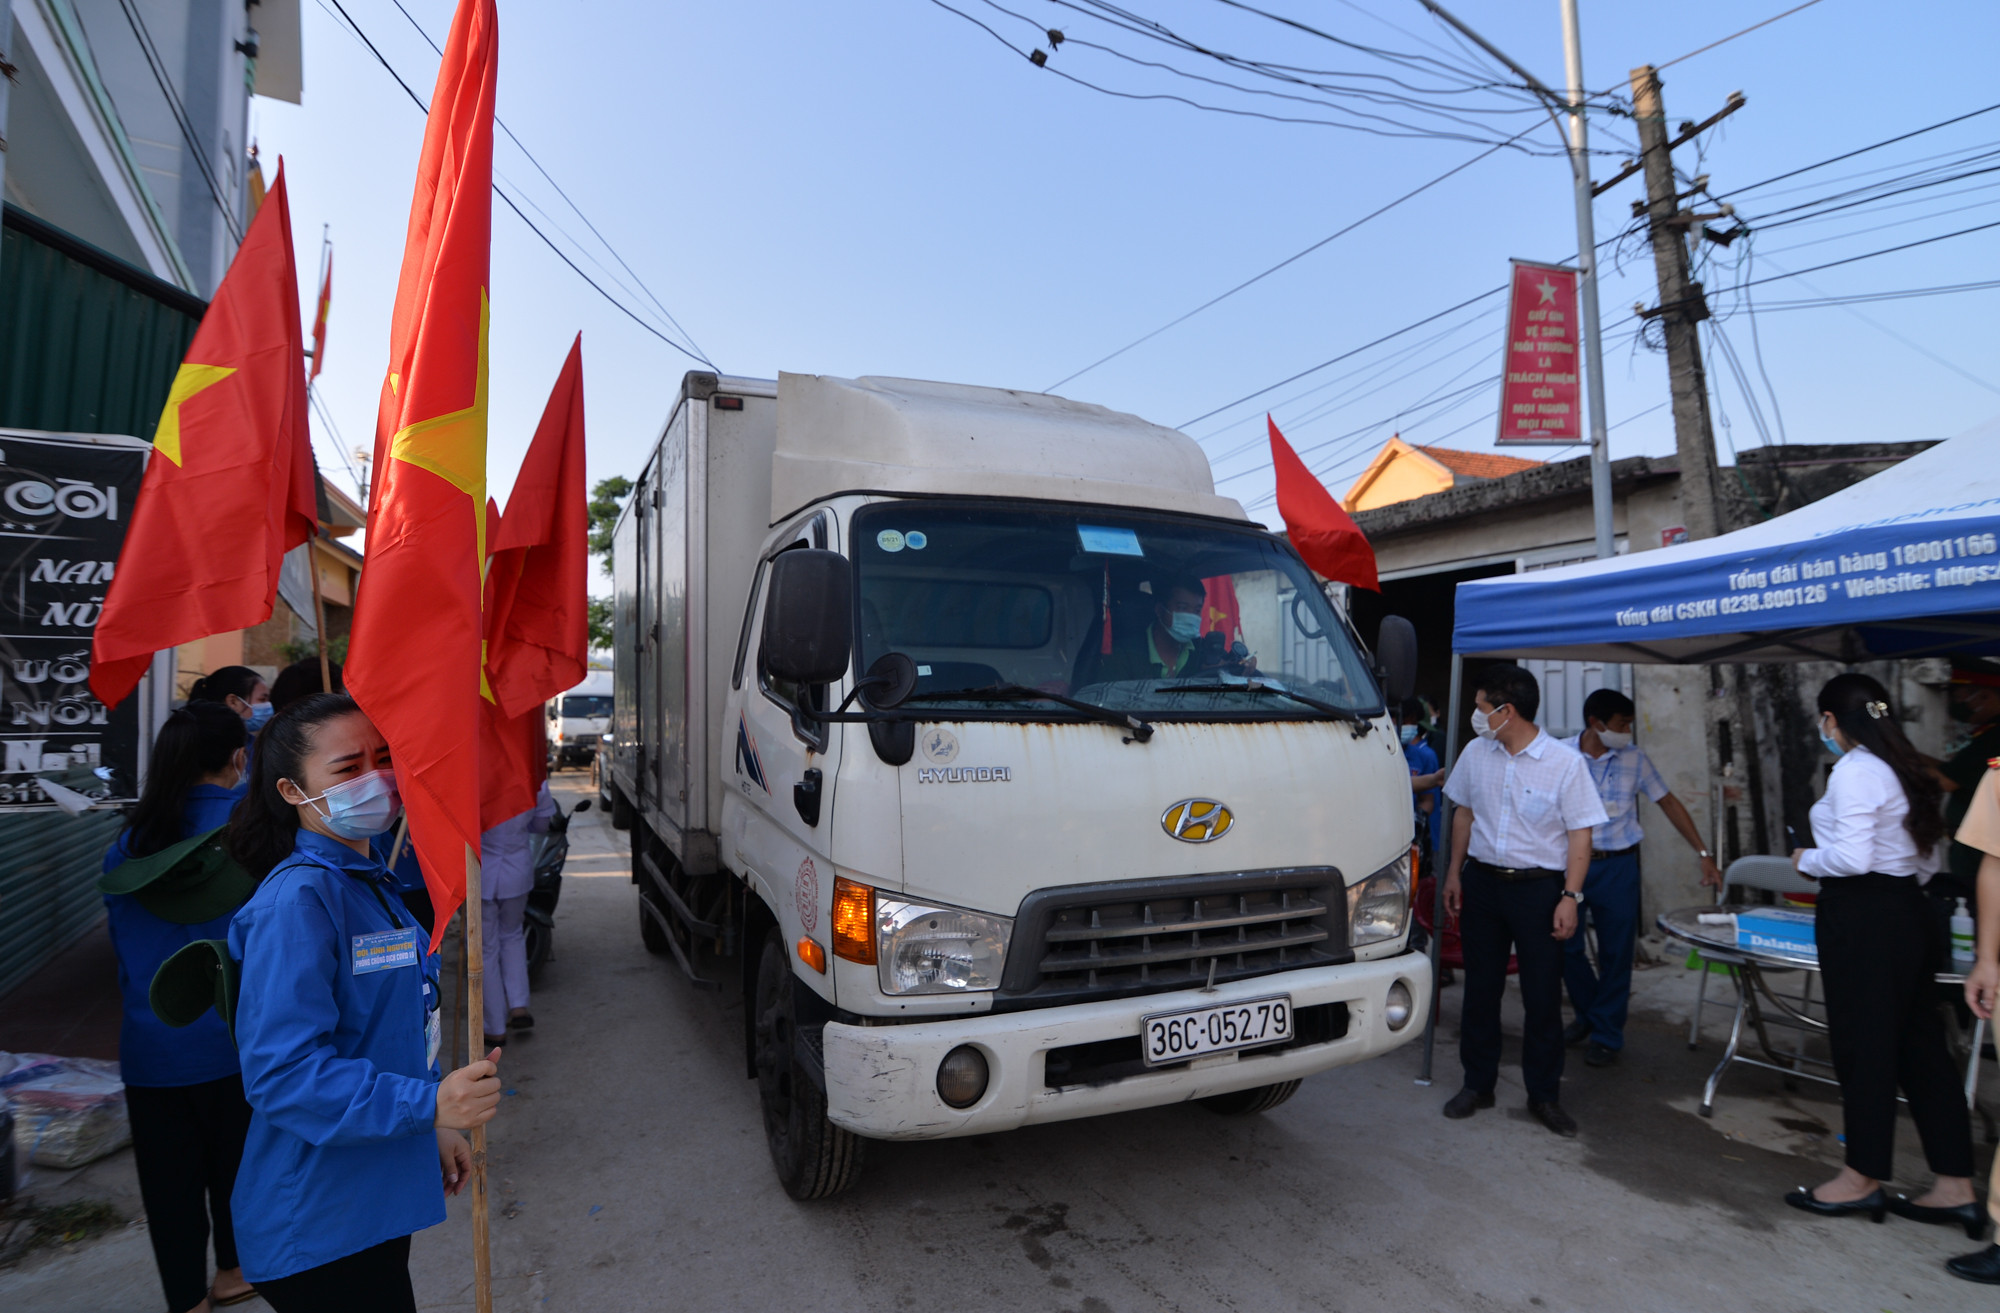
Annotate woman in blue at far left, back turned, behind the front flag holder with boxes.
[104,703,256,1313]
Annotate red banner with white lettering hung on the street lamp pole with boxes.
[1496,260,1590,446]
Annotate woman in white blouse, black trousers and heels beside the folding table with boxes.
[1784,675,1986,1239]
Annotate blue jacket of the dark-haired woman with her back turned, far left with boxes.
[104,785,244,1087]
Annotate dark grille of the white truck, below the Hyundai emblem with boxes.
[994,867,1354,1009]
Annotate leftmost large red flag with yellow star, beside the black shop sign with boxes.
[90,169,318,707]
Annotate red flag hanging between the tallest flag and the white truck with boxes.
[482,334,590,829]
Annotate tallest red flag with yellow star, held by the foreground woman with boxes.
[346,0,500,937]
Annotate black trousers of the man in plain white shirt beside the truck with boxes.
[1458,859,1562,1103]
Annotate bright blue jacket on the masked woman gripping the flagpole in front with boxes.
[230,831,444,1281]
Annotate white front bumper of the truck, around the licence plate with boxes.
[824,953,1430,1139]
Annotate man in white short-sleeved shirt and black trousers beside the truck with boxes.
[1444,665,1606,1135]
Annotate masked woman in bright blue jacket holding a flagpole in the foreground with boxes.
[228,693,500,1313]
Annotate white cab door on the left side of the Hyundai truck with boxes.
[722,510,844,995]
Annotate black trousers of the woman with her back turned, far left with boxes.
[126,1077,250,1313]
